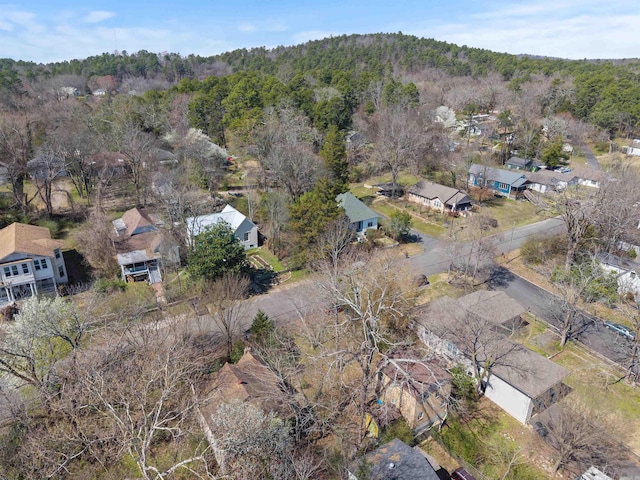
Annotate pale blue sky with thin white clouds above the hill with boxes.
[0,0,640,63]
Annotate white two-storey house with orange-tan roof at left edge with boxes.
[0,223,69,305]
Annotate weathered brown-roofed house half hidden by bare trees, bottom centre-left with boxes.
[196,348,294,476]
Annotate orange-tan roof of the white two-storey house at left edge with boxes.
[0,222,64,260]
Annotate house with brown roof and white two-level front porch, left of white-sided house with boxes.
[112,208,172,284]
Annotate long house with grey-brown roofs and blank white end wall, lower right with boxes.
[413,292,569,423]
